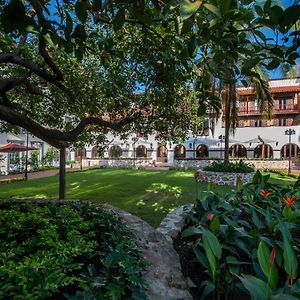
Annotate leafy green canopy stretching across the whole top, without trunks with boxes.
[0,0,300,148]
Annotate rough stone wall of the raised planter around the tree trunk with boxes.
[196,170,255,185]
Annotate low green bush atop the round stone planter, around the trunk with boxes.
[203,160,254,173]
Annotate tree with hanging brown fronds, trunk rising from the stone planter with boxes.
[173,0,300,163]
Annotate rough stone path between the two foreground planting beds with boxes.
[105,205,193,300]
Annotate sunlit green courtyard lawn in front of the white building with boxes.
[0,169,231,226]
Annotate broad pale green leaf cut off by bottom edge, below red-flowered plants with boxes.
[239,275,271,300]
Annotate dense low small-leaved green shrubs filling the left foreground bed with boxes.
[0,203,145,299]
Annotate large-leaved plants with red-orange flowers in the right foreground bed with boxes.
[182,171,300,300]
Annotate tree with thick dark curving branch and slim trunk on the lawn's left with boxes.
[0,0,205,198]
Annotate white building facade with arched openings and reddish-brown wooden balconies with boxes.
[0,77,300,173]
